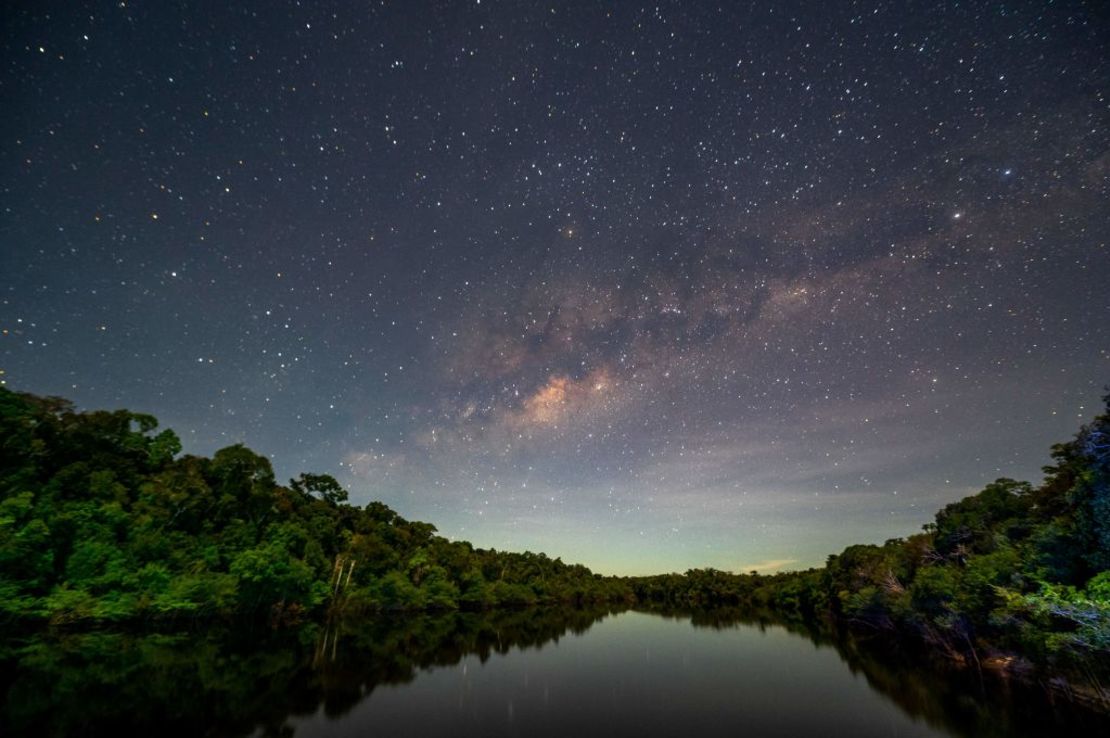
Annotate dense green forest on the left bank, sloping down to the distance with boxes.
[0,387,629,623]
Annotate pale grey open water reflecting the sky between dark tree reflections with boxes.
[292,613,946,737]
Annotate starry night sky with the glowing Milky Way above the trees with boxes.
[0,0,1110,574]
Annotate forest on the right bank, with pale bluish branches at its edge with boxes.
[630,395,1110,677]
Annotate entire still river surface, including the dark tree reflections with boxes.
[0,610,1110,738]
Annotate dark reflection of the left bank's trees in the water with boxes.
[0,608,611,738]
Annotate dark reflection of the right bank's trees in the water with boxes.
[650,607,1110,738]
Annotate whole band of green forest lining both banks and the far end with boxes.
[0,387,1110,692]
